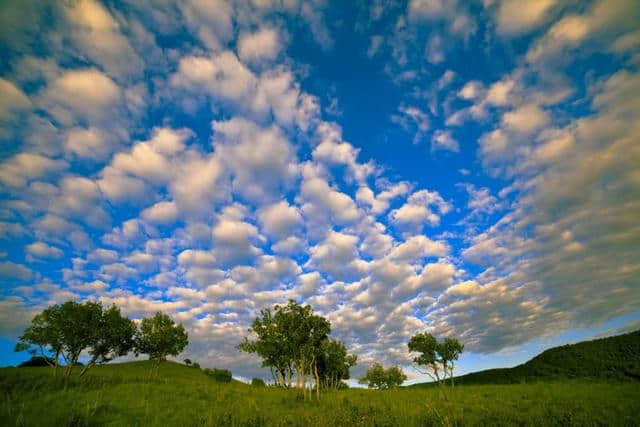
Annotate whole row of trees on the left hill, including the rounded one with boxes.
[15,301,189,377]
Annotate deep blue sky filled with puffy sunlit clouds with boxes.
[0,0,640,382]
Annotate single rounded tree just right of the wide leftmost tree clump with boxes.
[135,312,189,364]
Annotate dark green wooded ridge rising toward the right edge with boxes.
[411,330,640,387]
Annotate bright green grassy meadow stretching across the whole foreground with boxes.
[0,362,640,426]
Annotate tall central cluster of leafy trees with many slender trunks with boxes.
[238,300,357,399]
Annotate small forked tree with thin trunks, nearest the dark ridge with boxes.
[408,332,464,386]
